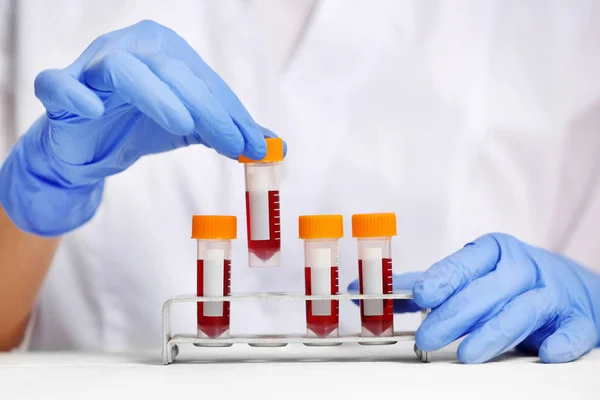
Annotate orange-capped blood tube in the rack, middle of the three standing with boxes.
[298,215,344,338]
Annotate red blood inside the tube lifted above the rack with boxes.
[246,190,281,261]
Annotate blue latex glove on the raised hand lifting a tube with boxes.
[0,21,282,236]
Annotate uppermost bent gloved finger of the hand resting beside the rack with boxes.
[413,235,500,308]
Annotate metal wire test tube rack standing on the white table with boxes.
[162,292,431,365]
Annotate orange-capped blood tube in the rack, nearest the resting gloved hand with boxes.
[352,213,397,337]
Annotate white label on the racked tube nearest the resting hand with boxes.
[362,247,383,315]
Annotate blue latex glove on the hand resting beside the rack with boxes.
[350,234,600,363]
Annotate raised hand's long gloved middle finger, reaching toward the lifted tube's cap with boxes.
[137,54,246,157]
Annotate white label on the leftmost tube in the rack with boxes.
[203,249,225,317]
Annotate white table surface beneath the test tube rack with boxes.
[0,342,600,400]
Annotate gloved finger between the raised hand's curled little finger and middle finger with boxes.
[83,51,194,135]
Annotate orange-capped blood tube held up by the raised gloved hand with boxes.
[239,138,283,267]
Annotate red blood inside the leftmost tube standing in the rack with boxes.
[197,260,231,339]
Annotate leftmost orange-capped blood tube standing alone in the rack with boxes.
[192,215,237,339]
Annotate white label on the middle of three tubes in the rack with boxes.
[309,249,331,315]
